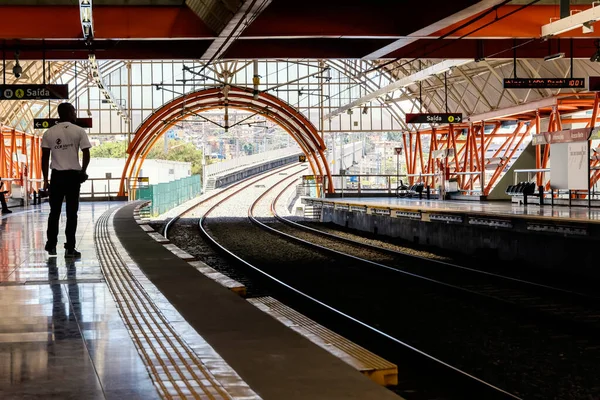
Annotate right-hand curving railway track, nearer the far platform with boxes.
[270,180,600,336]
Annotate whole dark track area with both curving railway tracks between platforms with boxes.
[163,167,600,400]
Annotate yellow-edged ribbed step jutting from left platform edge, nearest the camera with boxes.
[248,297,398,386]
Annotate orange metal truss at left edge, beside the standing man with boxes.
[0,125,42,192]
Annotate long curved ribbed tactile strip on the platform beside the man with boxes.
[95,209,260,400]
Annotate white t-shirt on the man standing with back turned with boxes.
[42,122,92,171]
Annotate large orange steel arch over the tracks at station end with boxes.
[119,86,333,196]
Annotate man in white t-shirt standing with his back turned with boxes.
[42,103,92,257]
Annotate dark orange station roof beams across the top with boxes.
[0,0,600,60]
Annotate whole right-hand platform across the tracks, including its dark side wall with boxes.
[302,197,600,276]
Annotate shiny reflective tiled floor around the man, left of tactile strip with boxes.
[0,203,159,400]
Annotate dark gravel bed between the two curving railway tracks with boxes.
[209,183,600,399]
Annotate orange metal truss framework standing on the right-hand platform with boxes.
[403,94,600,196]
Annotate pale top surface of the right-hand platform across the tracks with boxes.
[316,197,600,223]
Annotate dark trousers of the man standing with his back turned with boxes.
[46,169,81,250]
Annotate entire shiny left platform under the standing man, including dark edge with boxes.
[0,202,399,400]
